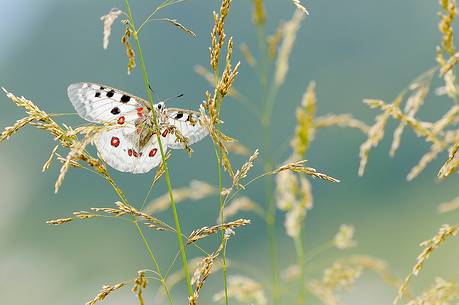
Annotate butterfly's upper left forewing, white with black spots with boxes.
[67,83,147,125]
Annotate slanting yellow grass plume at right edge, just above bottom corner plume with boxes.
[394,224,459,303]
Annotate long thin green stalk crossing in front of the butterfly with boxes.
[124,0,193,297]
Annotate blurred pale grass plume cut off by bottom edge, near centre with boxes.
[213,275,268,305]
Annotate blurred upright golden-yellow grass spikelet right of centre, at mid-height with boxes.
[290,82,317,158]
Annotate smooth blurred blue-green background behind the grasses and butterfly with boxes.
[0,0,459,305]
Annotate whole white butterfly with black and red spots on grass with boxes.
[67,82,208,174]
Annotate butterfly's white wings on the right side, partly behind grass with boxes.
[166,108,209,149]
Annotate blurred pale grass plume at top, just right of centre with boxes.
[274,10,304,87]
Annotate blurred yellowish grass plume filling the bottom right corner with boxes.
[406,277,459,305]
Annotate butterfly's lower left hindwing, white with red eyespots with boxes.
[96,127,167,174]
